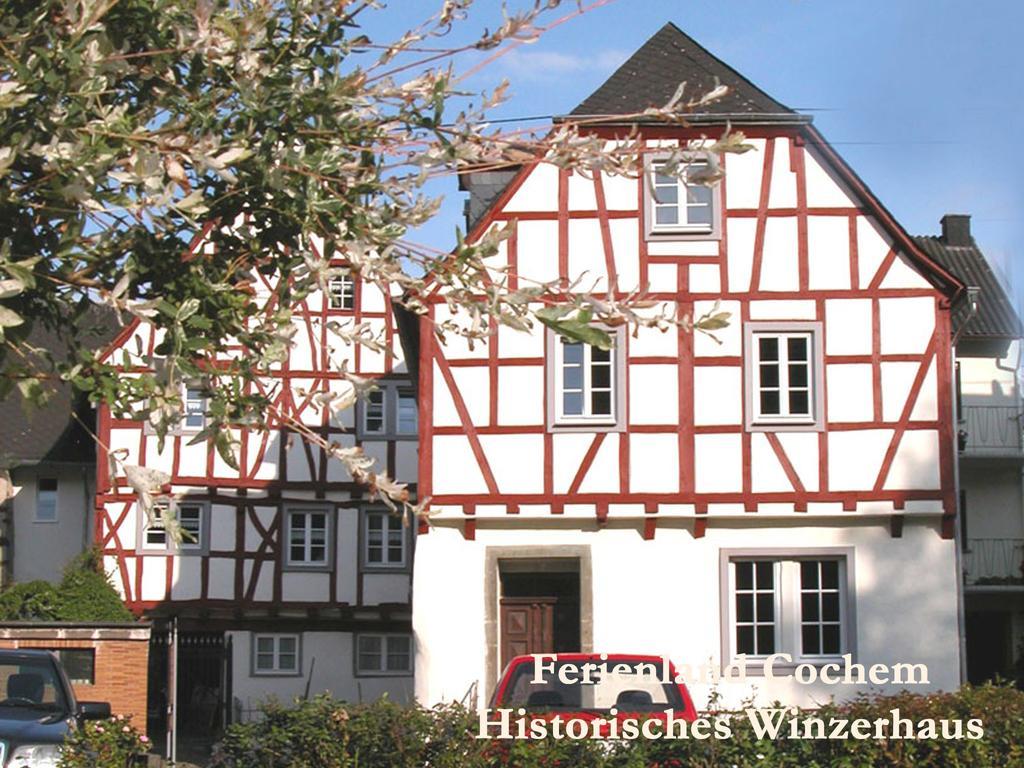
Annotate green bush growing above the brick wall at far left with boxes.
[0,550,134,623]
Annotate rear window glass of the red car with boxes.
[499,659,684,713]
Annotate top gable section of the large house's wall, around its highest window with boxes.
[471,127,961,296]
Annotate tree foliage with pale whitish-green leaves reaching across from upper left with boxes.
[0,0,746,524]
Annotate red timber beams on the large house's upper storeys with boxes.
[420,126,963,538]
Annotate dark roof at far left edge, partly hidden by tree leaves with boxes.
[0,306,120,468]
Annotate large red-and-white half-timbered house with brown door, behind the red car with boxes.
[410,25,966,709]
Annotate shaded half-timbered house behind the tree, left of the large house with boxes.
[95,239,417,730]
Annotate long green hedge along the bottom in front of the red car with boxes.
[211,685,1024,768]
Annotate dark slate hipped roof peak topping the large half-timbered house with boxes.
[571,23,797,117]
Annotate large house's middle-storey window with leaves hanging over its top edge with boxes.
[548,331,625,429]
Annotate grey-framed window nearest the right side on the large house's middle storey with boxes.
[743,323,824,430]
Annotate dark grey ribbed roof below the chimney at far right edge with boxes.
[913,236,1024,339]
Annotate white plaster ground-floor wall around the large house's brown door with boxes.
[413,523,958,709]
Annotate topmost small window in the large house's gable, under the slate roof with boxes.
[644,156,720,240]
